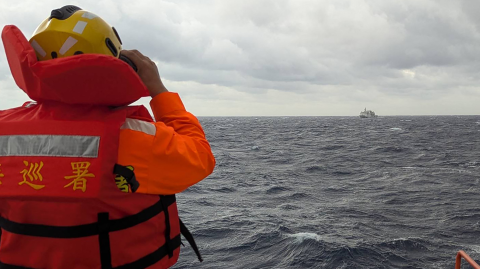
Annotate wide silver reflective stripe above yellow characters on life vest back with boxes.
[0,135,100,158]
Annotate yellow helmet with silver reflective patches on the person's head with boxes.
[29,5,122,61]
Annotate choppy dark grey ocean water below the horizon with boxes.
[174,116,480,269]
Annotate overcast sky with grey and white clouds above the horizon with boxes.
[0,0,480,116]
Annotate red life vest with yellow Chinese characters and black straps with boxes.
[0,26,199,268]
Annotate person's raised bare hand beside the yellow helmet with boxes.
[120,50,168,98]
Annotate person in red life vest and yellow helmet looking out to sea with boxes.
[0,6,215,268]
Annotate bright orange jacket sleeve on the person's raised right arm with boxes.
[118,92,215,195]
